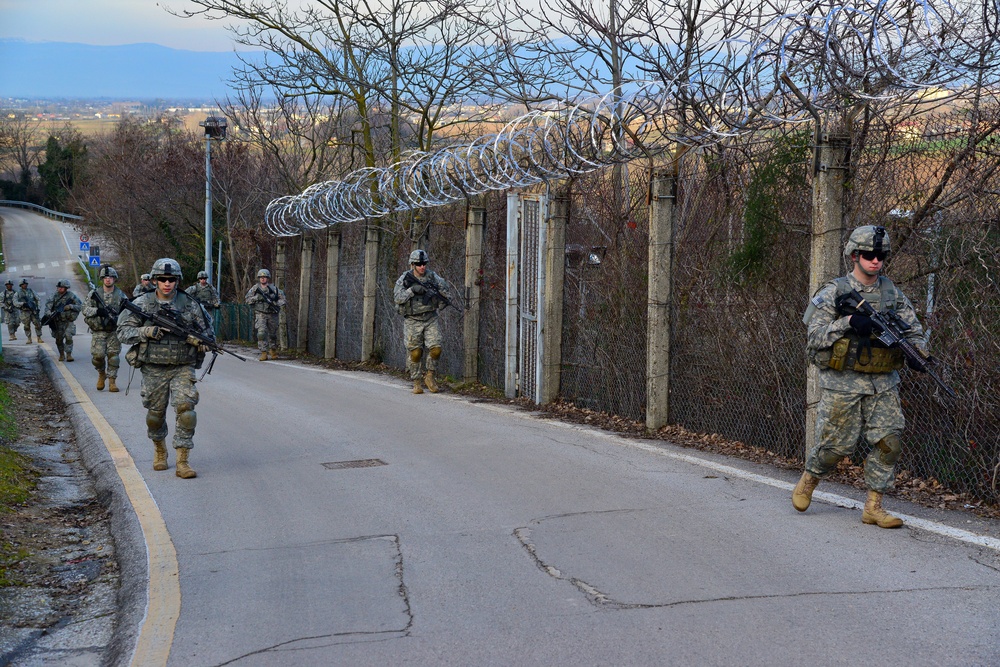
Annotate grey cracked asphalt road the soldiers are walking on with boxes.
[2,210,1000,667]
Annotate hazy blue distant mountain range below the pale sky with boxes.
[0,39,250,100]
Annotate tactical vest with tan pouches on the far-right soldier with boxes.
[812,276,905,373]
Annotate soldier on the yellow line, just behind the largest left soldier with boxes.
[83,266,128,393]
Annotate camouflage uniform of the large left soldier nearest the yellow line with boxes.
[118,292,214,449]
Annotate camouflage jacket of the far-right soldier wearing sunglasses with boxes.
[806,274,926,394]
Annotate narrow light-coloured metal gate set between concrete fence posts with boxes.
[504,193,548,402]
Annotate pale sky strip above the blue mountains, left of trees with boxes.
[0,0,233,51]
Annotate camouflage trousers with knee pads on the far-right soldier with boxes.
[806,387,906,493]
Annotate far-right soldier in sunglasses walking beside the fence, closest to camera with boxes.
[792,225,926,528]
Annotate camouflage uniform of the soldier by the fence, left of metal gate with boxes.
[392,269,448,381]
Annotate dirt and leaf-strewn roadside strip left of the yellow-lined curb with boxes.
[0,346,119,666]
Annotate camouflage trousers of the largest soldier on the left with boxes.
[140,364,198,449]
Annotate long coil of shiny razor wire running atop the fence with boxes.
[265,0,1000,236]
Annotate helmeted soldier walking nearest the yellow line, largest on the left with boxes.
[118,257,214,479]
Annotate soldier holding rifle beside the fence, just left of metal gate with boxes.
[393,250,448,394]
